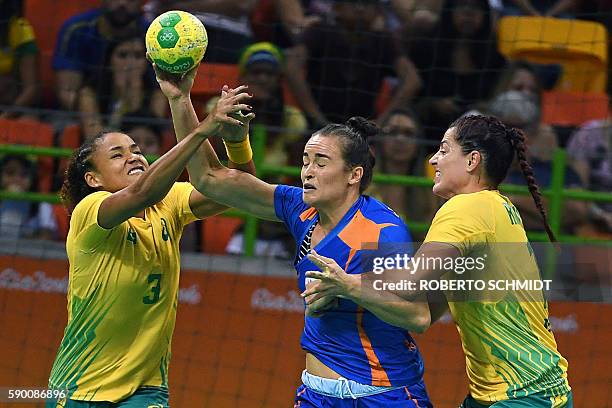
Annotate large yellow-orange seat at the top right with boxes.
[498,17,608,93]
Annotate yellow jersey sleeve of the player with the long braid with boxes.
[424,195,494,256]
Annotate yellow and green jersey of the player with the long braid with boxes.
[425,190,570,403]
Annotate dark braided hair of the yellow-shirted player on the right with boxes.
[450,115,557,242]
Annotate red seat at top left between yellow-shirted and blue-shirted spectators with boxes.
[23,0,100,107]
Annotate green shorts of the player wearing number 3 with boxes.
[46,387,170,408]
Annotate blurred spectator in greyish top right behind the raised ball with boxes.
[156,0,257,64]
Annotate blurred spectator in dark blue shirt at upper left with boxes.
[53,0,148,110]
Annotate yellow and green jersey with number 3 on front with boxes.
[49,183,196,402]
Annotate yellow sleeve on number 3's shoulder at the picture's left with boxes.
[70,191,118,252]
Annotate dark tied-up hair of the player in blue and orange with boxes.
[313,116,379,194]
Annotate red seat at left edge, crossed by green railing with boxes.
[0,119,53,192]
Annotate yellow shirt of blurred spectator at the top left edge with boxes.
[0,17,38,75]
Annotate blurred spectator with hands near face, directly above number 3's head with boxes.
[79,36,168,138]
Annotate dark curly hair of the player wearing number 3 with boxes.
[60,131,108,214]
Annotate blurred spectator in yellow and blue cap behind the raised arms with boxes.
[207,42,306,258]
